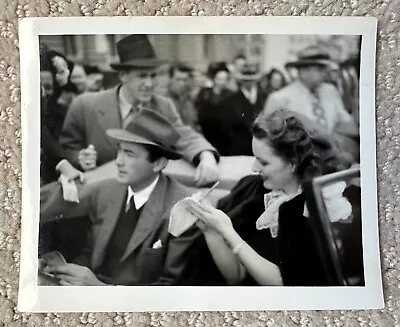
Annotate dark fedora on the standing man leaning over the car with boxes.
[110,34,164,70]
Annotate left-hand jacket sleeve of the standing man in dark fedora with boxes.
[60,96,87,168]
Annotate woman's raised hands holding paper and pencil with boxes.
[188,201,233,236]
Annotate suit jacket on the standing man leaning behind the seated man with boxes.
[60,86,217,167]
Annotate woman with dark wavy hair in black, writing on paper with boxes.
[189,110,348,286]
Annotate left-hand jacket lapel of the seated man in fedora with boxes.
[92,184,127,268]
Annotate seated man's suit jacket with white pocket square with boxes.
[40,174,200,285]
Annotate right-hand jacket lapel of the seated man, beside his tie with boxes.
[121,174,167,262]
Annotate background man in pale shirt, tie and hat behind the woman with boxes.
[264,46,359,160]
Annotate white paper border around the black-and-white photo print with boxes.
[18,17,384,312]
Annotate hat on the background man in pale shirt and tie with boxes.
[286,45,338,68]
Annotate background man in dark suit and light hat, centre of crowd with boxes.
[214,62,267,156]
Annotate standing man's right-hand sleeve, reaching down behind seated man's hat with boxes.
[159,99,219,165]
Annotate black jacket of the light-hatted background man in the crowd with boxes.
[218,89,267,156]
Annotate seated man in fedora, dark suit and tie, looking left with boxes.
[40,109,199,285]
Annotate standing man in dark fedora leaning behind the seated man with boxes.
[60,35,219,186]
